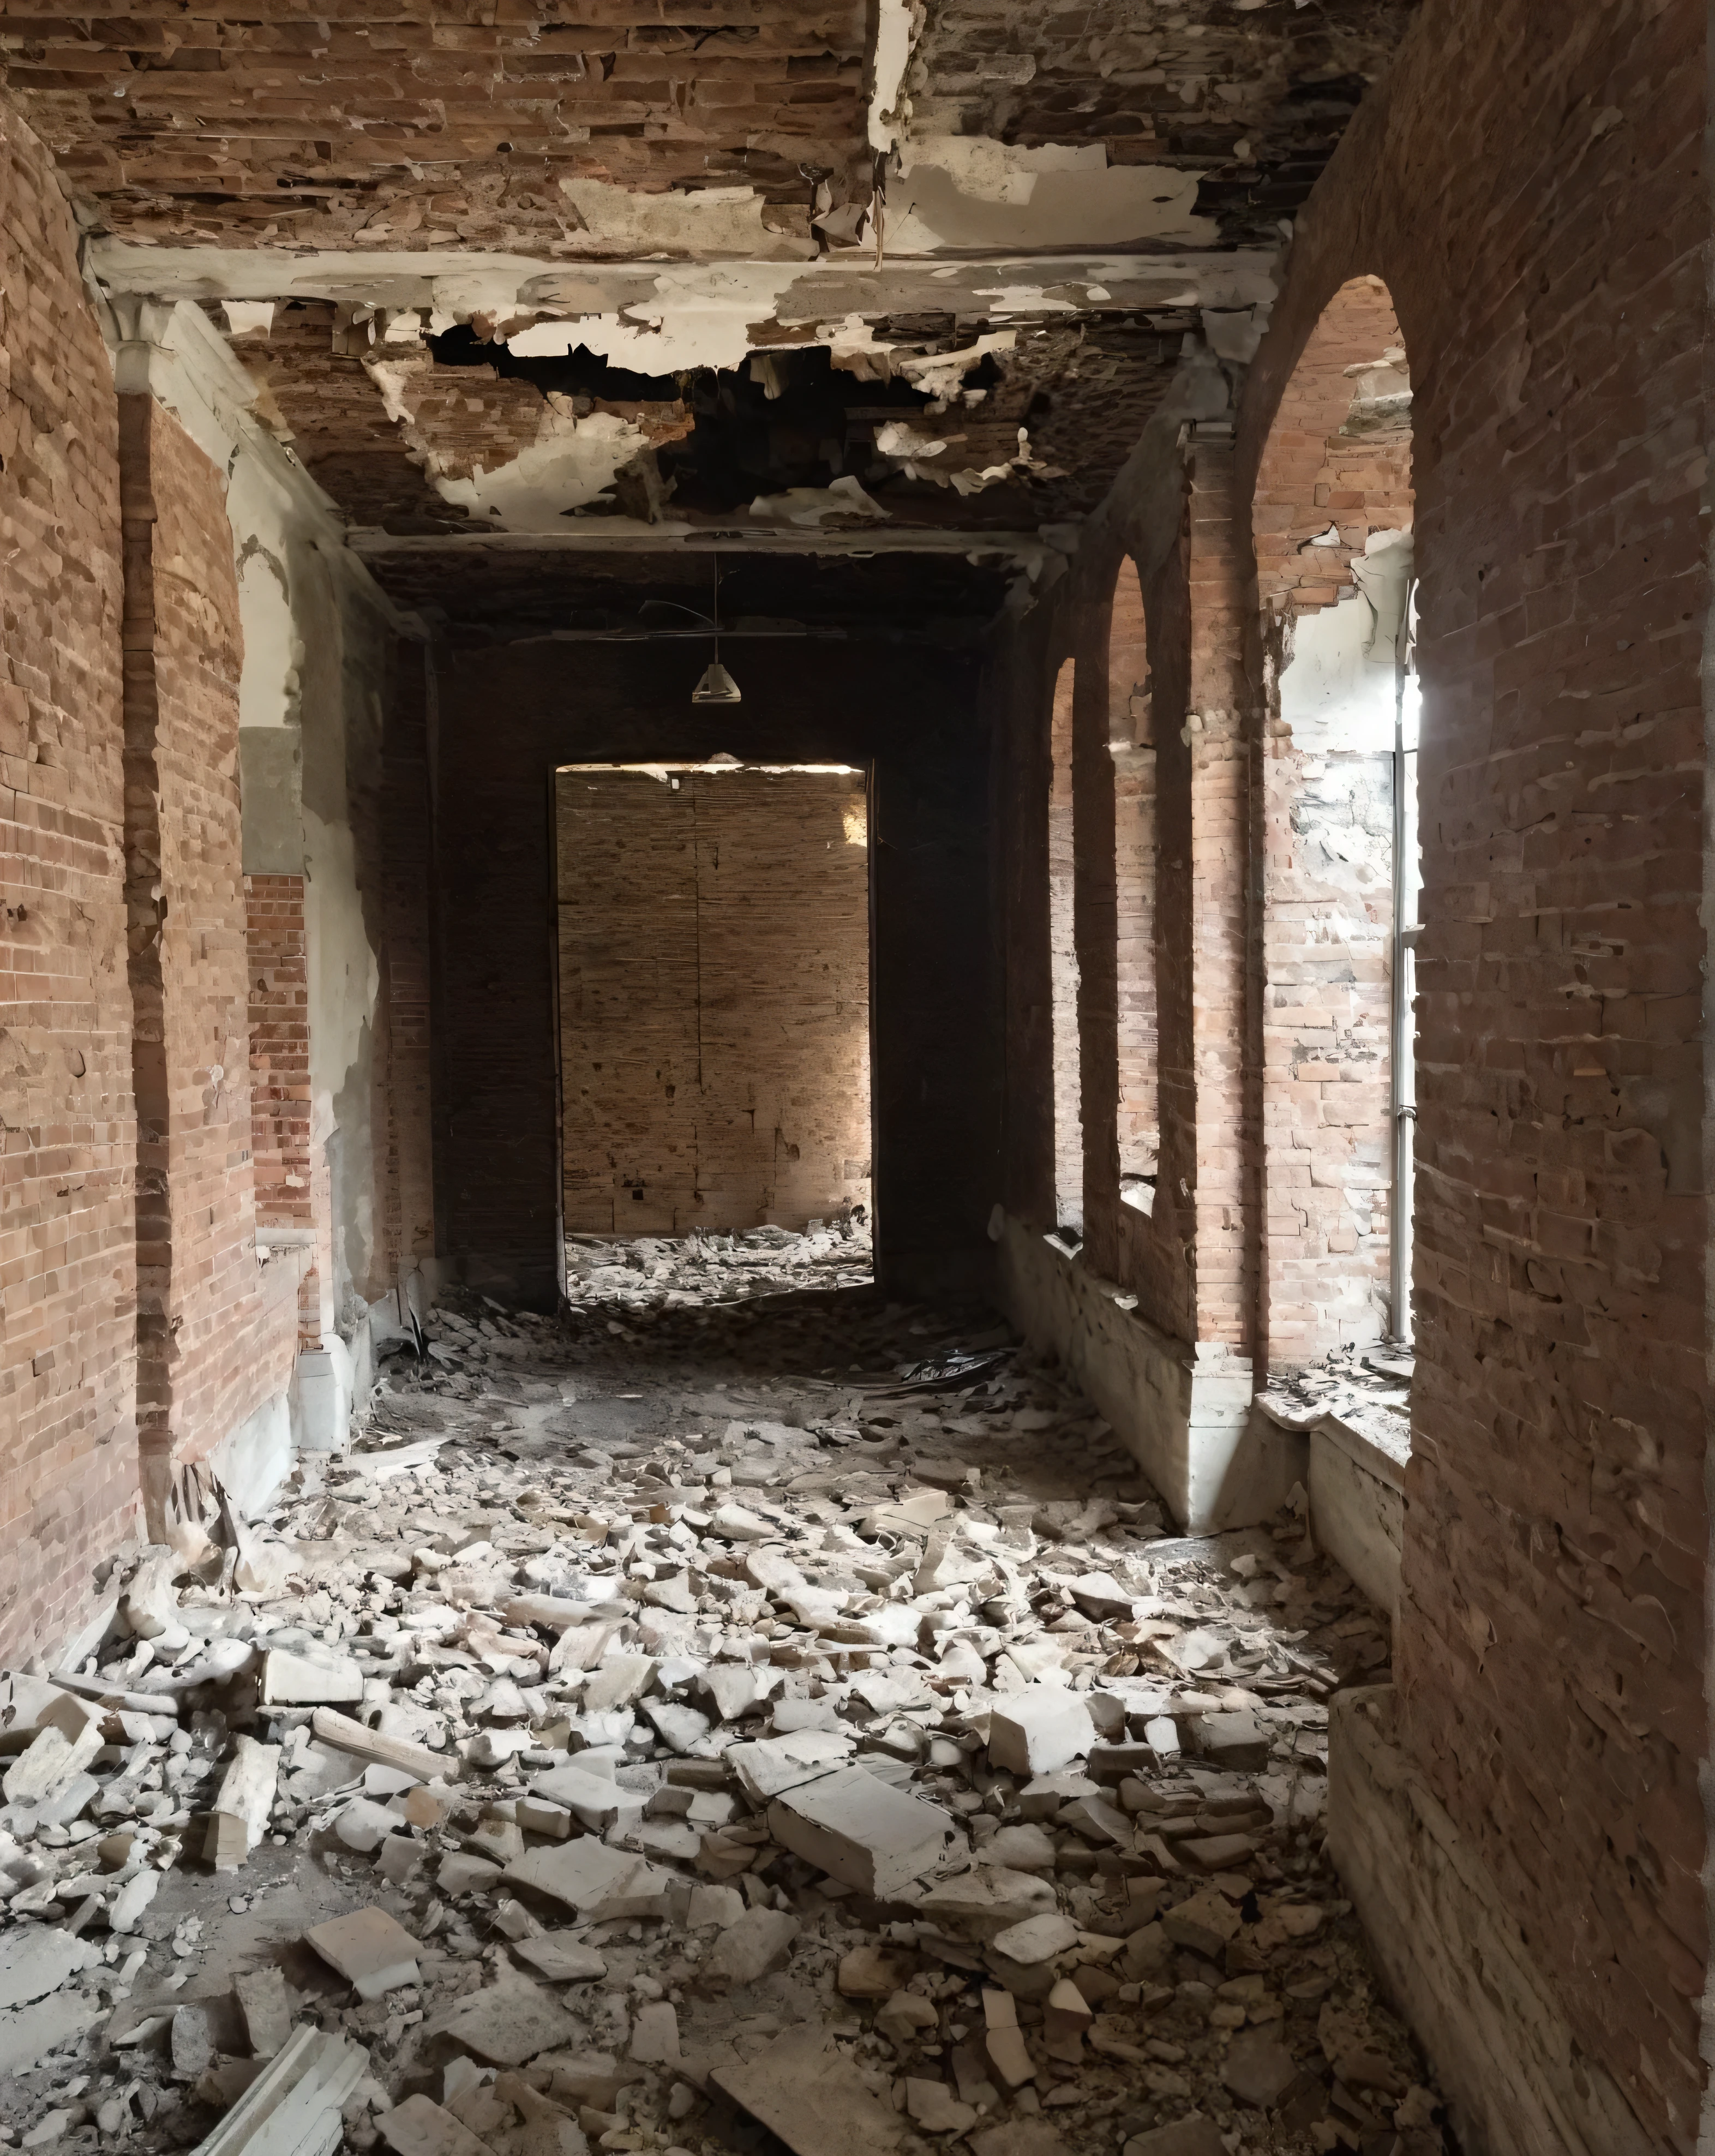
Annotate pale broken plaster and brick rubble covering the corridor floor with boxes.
[0,1237,1443,2156]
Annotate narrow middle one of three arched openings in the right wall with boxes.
[1107,561,1161,1214]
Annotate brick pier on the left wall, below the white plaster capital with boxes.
[118,397,297,1518]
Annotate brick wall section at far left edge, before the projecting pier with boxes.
[0,104,136,1662]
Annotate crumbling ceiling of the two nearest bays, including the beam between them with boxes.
[0,0,1411,610]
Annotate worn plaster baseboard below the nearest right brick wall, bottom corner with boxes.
[1327,1684,1659,2156]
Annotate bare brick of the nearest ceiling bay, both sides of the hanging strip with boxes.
[0,0,1413,252]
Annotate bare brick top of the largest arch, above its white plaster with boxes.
[1252,276,1413,621]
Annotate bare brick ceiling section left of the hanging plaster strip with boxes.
[0,0,864,250]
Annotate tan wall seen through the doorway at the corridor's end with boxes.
[556,772,871,1235]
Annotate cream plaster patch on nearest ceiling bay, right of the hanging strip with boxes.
[888,136,1220,254]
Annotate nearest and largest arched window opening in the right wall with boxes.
[1254,276,1418,1371]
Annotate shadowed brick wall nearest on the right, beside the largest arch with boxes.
[1241,0,1708,2152]
